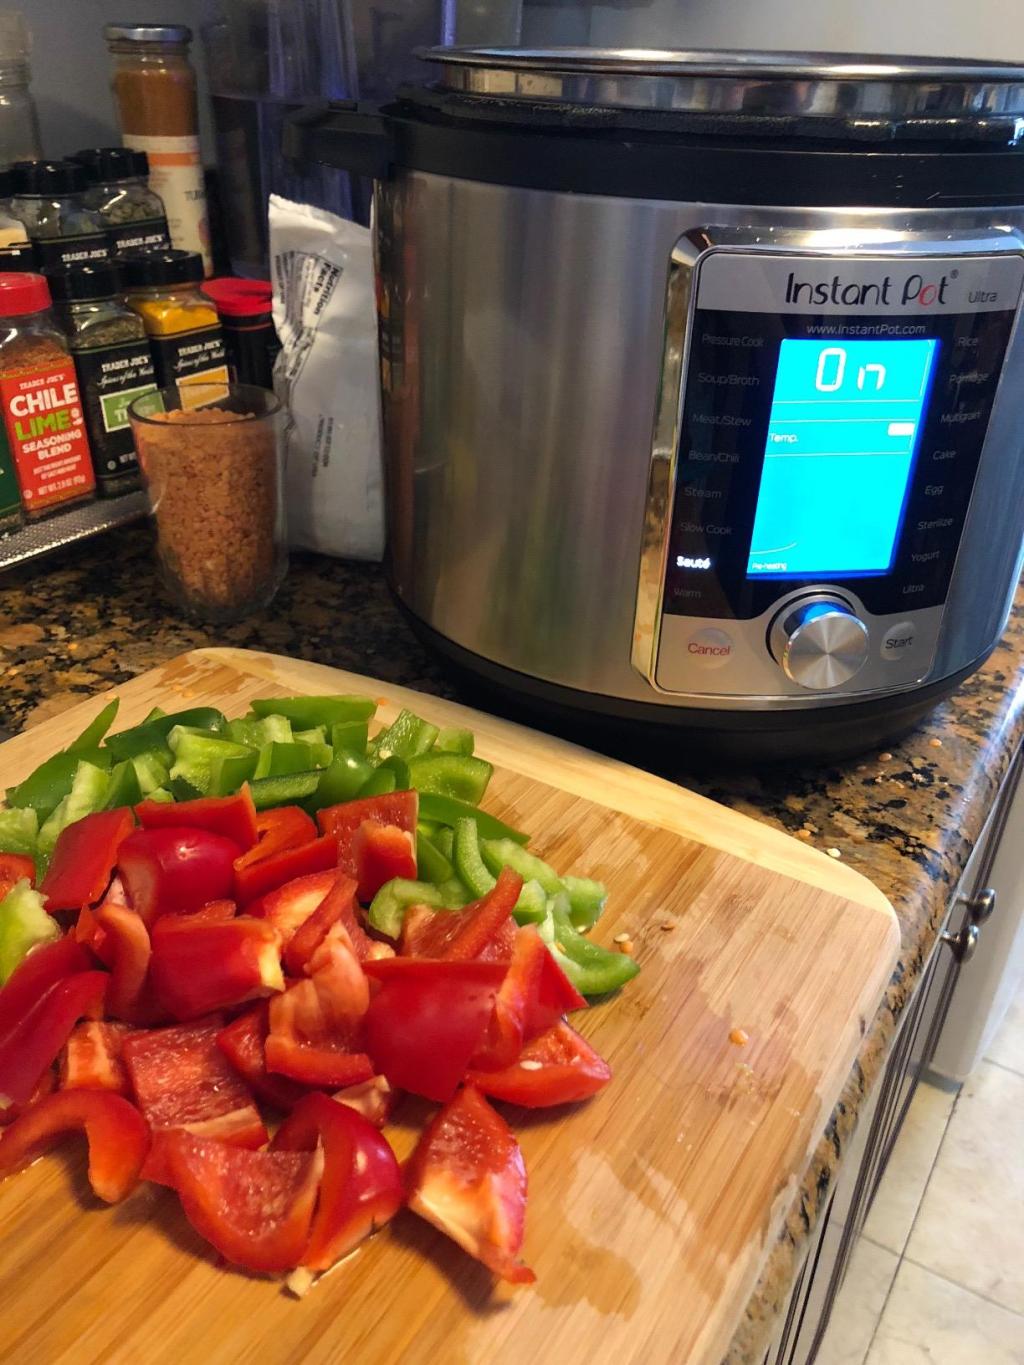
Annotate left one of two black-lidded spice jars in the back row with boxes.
[11,161,109,270]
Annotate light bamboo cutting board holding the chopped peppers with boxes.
[0,650,898,1365]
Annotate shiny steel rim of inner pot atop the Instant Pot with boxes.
[419,48,1024,121]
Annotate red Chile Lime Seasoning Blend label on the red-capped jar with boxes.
[0,359,96,515]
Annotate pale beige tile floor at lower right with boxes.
[816,991,1024,1365]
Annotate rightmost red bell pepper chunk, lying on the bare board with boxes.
[467,1020,612,1108]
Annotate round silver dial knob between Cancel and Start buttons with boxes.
[769,592,868,692]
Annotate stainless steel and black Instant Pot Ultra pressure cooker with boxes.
[291,48,1024,755]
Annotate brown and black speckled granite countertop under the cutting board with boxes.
[0,527,1024,1365]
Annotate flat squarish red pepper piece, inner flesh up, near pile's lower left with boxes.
[123,1018,266,1162]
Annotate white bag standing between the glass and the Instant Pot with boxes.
[270,194,384,560]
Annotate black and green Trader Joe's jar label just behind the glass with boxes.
[75,341,157,485]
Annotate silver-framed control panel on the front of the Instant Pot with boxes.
[655,250,1024,695]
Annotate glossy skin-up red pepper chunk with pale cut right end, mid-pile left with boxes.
[149,915,284,1021]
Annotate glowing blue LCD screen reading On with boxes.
[747,337,938,579]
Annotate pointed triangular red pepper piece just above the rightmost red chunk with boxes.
[472,924,587,1070]
